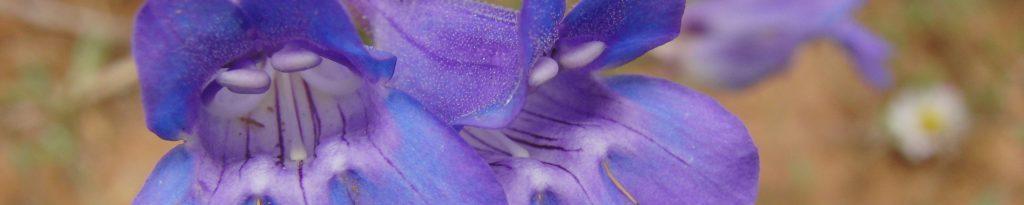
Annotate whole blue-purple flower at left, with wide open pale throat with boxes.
[132,0,505,204]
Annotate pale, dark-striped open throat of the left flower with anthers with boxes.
[196,45,365,164]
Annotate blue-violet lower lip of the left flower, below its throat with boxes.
[135,89,505,204]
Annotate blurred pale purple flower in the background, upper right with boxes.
[659,0,891,89]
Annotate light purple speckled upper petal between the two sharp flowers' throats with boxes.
[349,0,562,127]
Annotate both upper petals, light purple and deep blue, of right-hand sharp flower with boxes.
[346,0,683,127]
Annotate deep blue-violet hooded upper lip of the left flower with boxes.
[132,0,395,140]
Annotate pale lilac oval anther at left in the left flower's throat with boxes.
[217,69,270,94]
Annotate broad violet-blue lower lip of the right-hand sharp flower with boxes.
[464,73,759,204]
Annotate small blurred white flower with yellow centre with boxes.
[886,83,970,163]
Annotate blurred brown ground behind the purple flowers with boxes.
[0,0,1024,204]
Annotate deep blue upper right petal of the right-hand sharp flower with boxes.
[556,0,685,70]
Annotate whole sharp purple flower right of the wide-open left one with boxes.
[348,0,759,204]
